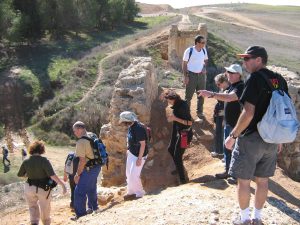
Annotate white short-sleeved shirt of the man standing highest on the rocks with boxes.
[182,46,208,73]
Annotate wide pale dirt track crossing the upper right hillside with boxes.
[195,7,300,38]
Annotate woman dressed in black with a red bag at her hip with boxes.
[164,90,193,184]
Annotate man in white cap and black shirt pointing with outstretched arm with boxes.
[199,64,244,183]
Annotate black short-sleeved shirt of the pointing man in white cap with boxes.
[224,81,245,127]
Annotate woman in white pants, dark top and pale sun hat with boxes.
[120,111,148,200]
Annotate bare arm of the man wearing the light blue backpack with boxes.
[225,102,255,149]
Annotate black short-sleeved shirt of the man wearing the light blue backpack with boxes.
[240,68,288,135]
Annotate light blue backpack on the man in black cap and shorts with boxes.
[257,72,299,144]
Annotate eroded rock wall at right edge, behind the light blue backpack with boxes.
[269,66,300,181]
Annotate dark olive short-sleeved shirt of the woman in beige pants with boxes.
[18,155,55,180]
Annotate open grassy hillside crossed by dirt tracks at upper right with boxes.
[190,4,300,73]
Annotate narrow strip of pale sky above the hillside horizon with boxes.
[136,0,300,8]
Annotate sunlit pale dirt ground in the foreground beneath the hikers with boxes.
[0,99,300,225]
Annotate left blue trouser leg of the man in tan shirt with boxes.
[74,170,89,217]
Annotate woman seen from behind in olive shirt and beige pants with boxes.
[18,141,66,225]
